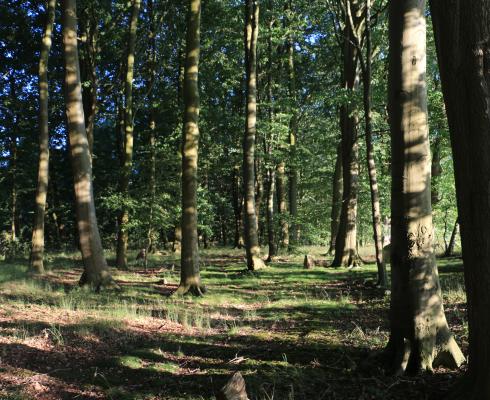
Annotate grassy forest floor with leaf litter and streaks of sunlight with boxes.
[0,248,467,400]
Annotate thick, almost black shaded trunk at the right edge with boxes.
[431,0,490,394]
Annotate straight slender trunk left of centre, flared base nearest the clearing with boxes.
[177,0,202,295]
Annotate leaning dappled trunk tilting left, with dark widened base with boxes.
[63,0,113,289]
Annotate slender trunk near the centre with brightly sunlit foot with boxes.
[243,0,264,271]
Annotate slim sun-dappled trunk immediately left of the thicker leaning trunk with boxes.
[29,0,56,274]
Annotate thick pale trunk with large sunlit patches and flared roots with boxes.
[387,0,464,374]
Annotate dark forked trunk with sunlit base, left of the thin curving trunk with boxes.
[332,0,362,267]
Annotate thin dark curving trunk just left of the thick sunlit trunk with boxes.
[363,0,387,288]
